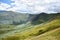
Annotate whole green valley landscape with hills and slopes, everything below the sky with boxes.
[0,11,60,40]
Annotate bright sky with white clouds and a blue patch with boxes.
[0,0,60,13]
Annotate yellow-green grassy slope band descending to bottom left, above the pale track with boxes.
[0,19,60,40]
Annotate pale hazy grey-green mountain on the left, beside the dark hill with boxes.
[0,11,29,25]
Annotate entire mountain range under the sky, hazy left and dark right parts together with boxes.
[0,11,60,25]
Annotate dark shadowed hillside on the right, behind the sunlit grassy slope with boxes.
[30,13,60,25]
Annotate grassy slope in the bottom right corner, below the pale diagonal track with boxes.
[26,28,60,40]
